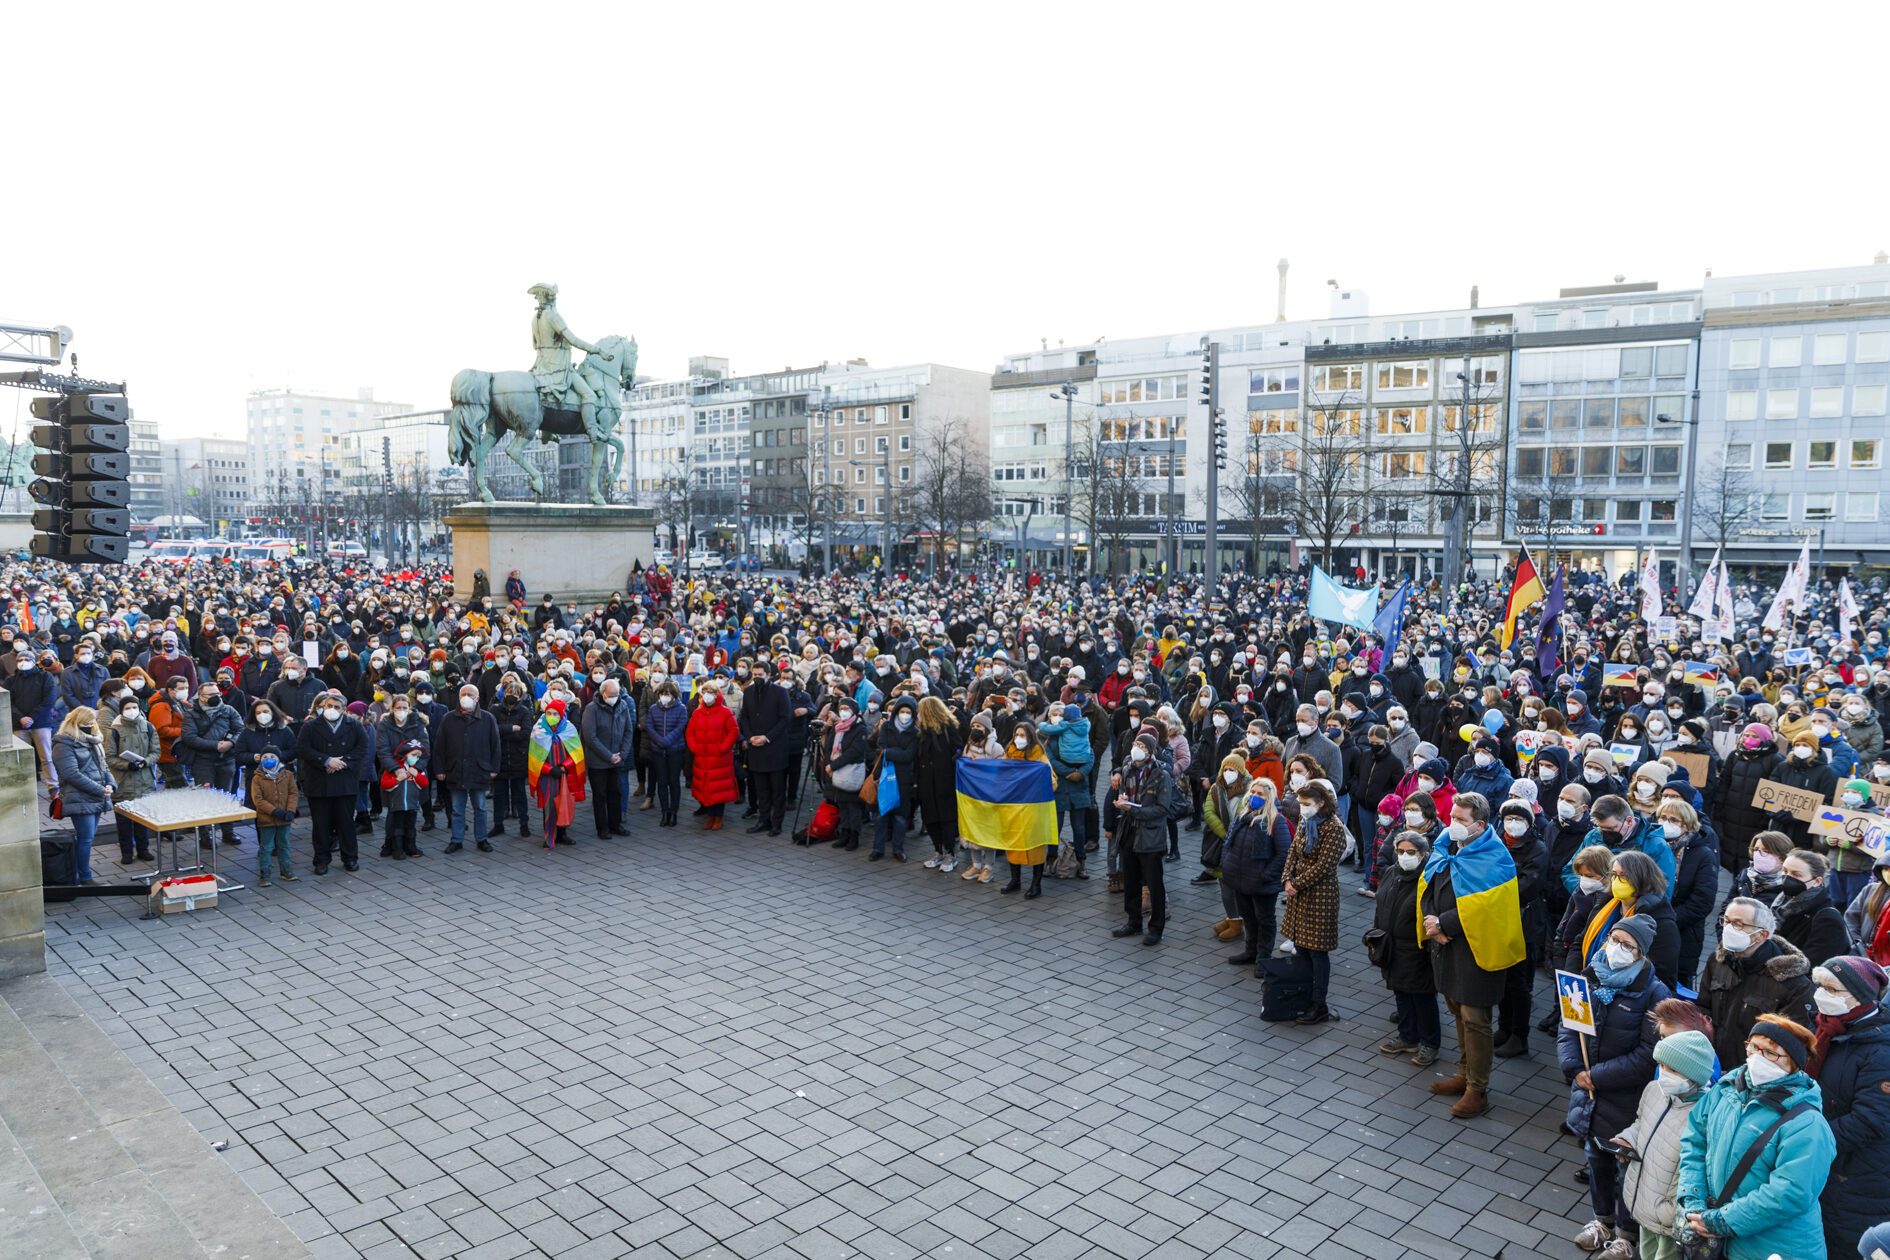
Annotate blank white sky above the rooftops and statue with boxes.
[0,2,1890,436]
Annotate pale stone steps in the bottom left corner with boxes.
[0,975,310,1260]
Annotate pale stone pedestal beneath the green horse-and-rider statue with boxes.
[446,501,656,603]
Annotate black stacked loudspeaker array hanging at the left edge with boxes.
[28,393,130,565]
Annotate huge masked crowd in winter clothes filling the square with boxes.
[11,563,1890,1260]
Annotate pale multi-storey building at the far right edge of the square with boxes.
[1692,264,1890,565]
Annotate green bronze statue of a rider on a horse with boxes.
[446,285,637,506]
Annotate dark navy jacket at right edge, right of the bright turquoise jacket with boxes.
[1818,1007,1890,1237]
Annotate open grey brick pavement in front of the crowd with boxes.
[33,797,1588,1260]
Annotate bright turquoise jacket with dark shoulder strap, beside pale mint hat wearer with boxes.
[1675,1067,1837,1260]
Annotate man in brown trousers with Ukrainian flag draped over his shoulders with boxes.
[1418,792,1525,1120]
